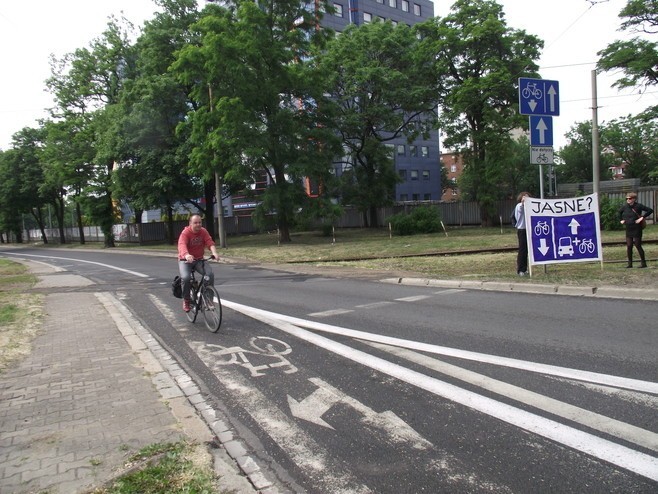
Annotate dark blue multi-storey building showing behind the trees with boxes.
[322,0,441,201]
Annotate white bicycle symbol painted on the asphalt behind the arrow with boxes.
[207,336,297,377]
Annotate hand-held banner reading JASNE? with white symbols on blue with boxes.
[524,194,602,264]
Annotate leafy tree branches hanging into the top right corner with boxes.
[597,0,658,100]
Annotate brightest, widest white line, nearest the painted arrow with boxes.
[220,301,658,481]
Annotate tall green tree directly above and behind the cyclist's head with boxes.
[113,0,204,242]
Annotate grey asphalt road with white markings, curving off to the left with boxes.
[2,249,658,493]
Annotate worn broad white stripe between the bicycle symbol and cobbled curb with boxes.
[188,341,371,494]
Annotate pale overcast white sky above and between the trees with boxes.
[0,0,658,149]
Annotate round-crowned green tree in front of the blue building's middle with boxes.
[317,21,438,227]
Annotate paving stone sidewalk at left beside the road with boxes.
[0,293,185,493]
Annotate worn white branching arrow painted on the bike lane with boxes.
[288,378,432,449]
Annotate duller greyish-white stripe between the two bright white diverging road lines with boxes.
[368,343,658,451]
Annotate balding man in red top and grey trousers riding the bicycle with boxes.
[178,214,219,312]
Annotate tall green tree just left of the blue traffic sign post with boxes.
[423,0,543,225]
